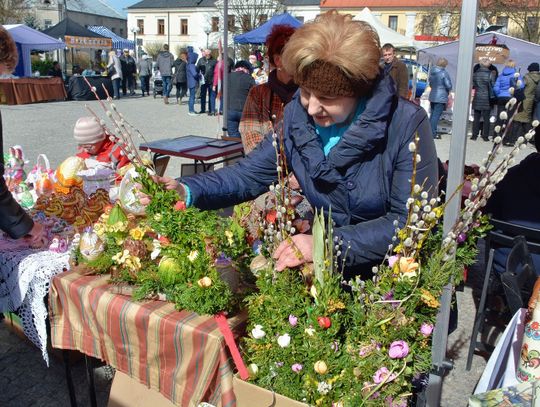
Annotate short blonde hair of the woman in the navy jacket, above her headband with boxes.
[282,10,381,87]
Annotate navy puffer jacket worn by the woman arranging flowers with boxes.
[181,78,437,278]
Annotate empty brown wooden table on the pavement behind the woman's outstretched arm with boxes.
[139,135,244,173]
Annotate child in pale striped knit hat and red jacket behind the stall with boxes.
[73,117,129,170]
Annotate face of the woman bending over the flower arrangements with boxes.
[300,87,358,127]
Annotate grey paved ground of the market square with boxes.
[0,97,532,407]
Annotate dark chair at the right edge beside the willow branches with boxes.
[466,219,540,370]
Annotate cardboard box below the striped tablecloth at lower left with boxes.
[107,370,175,407]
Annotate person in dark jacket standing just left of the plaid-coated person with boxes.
[227,61,255,137]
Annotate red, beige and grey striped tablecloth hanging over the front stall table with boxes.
[49,272,246,407]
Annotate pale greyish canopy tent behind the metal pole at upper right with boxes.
[418,32,540,83]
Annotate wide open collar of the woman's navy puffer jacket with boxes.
[289,76,397,184]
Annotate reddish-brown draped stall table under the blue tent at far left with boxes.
[0,78,67,105]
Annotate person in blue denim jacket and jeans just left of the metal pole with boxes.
[429,58,452,139]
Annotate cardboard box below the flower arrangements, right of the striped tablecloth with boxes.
[233,376,308,407]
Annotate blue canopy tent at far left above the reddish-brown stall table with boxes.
[4,24,66,76]
